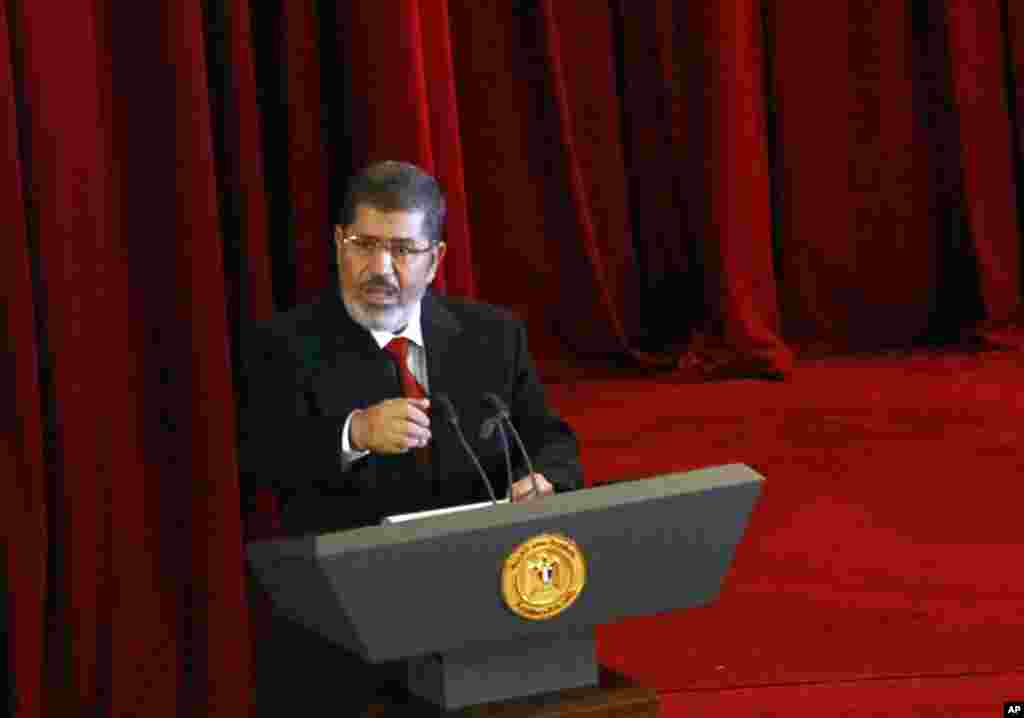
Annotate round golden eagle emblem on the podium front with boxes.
[502,534,587,621]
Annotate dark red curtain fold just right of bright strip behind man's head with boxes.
[449,3,574,357]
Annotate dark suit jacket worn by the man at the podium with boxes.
[234,289,583,535]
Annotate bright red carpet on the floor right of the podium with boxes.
[549,352,1024,717]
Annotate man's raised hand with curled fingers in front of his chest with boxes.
[349,398,430,454]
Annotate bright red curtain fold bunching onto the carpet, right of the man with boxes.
[680,0,793,377]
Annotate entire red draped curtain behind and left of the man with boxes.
[0,0,1024,717]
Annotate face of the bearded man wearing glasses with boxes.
[335,205,444,332]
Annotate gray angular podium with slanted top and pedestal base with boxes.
[248,464,763,710]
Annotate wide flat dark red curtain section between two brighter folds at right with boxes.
[772,2,937,353]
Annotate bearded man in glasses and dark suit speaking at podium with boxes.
[235,162,582,535]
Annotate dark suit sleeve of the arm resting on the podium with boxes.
[509,321,583,492]
